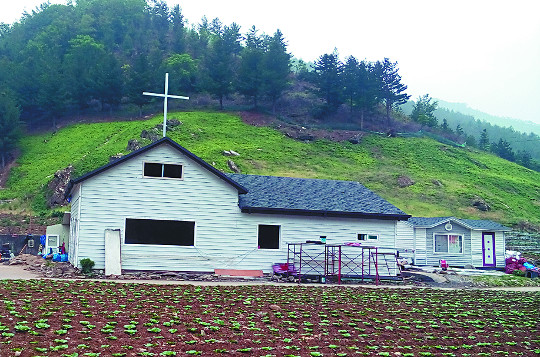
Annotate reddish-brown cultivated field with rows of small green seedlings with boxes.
[0,280,540,357]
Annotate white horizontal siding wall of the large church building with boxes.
[77,145,395,272]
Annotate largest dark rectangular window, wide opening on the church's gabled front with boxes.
[125,218,195,245]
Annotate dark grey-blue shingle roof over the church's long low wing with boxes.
[227,174,410,219]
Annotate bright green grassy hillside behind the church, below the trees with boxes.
[0,112,540,224]
